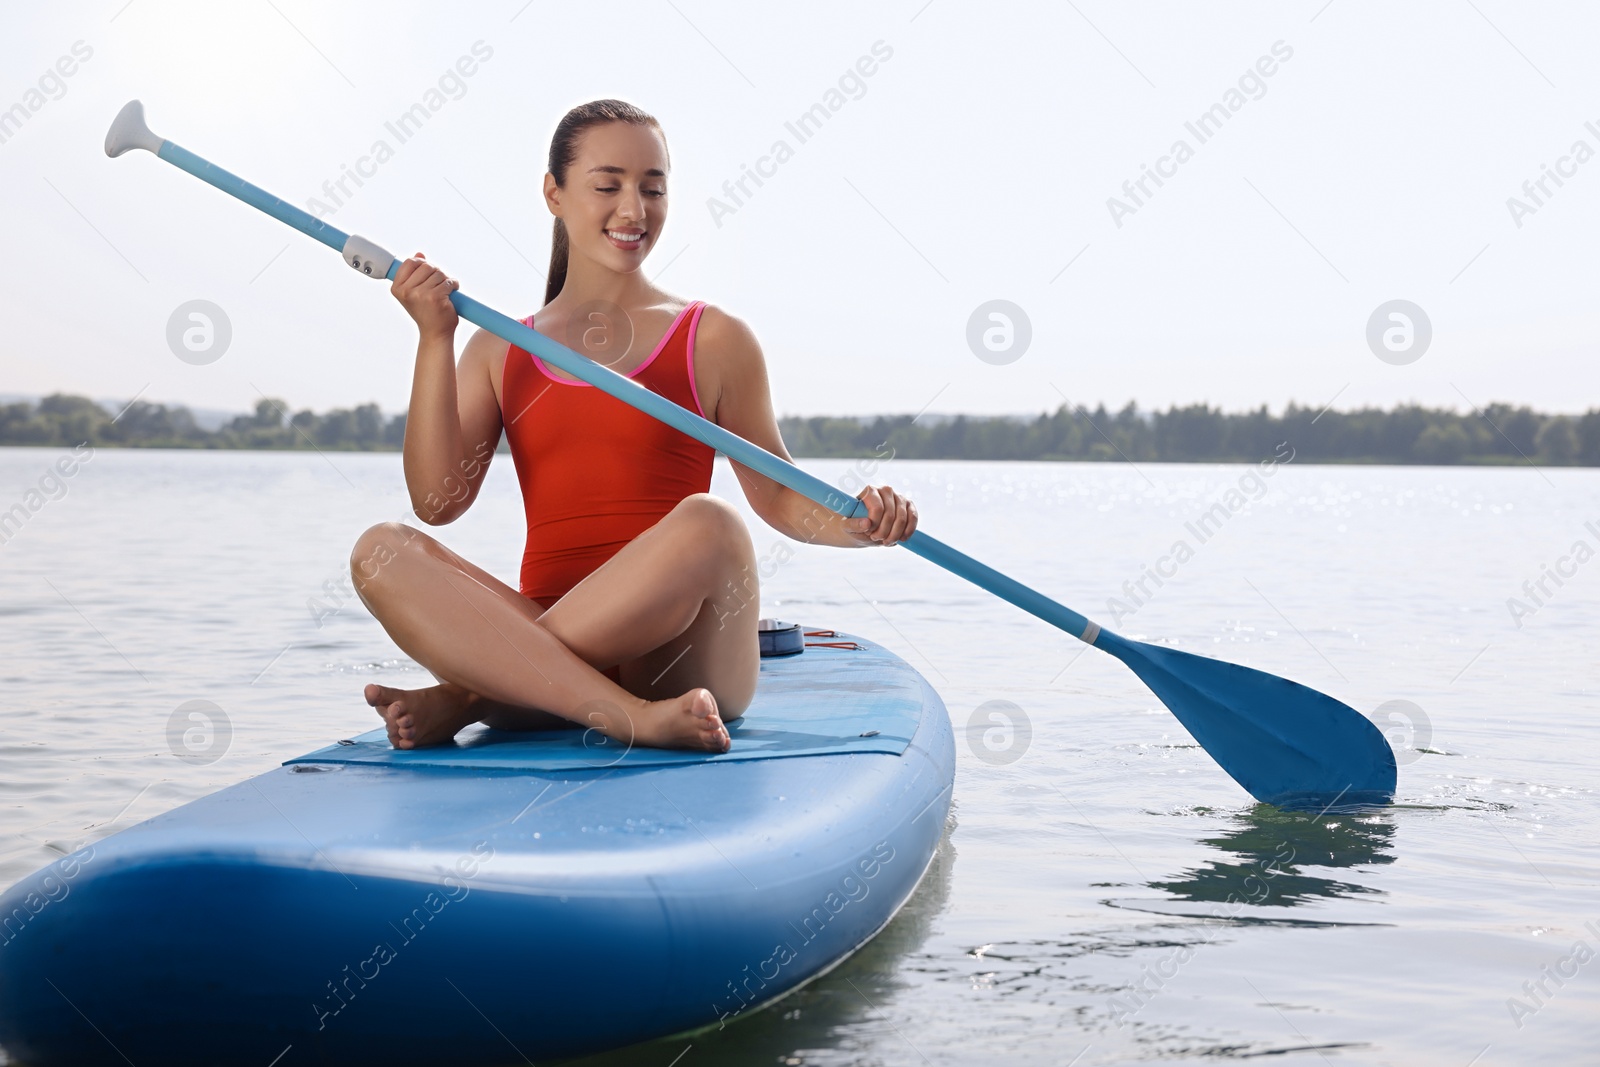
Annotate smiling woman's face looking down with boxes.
[544,122,667,274]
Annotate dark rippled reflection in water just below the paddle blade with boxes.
[1146,805,1395,907]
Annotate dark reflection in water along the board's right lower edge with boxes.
[563,811,955,1067]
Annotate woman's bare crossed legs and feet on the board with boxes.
[350,493,760,752]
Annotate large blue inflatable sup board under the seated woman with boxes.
[0,637,955,1067]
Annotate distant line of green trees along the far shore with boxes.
[0,394,1600,467]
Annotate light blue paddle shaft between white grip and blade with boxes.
[147,129,1099,645]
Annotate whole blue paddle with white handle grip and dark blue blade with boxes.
[106,101,1395,808]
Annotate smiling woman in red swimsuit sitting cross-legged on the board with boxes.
[350,101,917,752]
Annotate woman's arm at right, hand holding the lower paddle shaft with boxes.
[694,307,917,549]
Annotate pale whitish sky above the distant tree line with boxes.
[0,0,1600,414]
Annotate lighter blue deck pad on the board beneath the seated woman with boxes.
[286,645,923,771]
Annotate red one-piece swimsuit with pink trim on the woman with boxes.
[502,301,715,608]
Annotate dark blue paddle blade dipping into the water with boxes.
[1094,632,1395,809]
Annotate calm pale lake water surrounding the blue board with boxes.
[0,450,1600,1067]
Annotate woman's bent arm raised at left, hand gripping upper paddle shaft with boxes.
[390,258,506,526]
